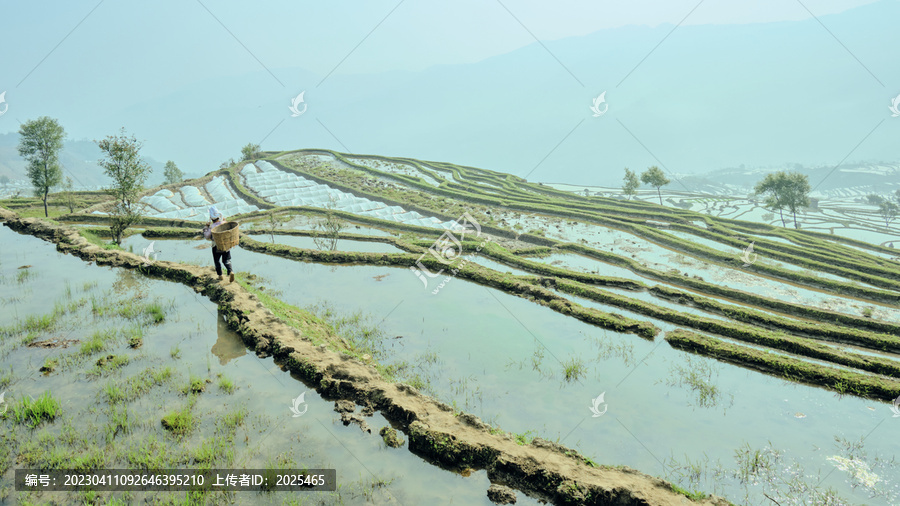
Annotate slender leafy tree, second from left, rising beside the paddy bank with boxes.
[95,128,151,244]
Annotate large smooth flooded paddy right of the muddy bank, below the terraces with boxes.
[59,223,900,504]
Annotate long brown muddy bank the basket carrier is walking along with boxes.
[0,208,729,505]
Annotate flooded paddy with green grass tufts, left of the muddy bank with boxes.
[0,227,537,504]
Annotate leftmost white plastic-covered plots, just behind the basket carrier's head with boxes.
[141,176,259,221]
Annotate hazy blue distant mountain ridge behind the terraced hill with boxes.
[0,0,900,186]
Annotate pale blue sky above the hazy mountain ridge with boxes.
[0,0,873,82]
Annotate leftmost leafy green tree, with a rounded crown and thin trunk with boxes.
[19,116,66,217]
